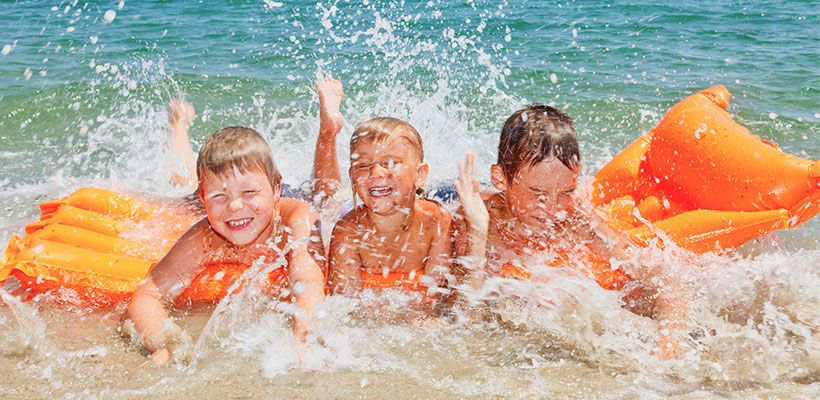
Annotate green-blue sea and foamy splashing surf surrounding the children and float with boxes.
[0,0,820,399]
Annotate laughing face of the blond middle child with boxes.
[350,137,428,214]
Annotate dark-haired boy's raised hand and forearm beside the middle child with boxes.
[453,153,490,290]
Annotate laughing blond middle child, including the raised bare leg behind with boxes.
[314,79,451,293]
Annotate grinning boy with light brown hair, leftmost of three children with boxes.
[128,127,324,363]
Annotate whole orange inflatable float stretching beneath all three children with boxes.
[0,86,820,306]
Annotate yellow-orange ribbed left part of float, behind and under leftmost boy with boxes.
[0,188,287,307]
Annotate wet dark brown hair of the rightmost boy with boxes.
[498,103,581,180]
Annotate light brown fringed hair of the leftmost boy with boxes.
[196,126,282,190]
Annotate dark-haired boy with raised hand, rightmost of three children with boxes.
[453,104,686,358]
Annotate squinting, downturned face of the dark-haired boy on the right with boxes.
[492,158,578,229]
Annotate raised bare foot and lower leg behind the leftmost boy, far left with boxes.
[168,100,196,187]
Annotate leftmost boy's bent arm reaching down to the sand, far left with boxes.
[128,219,208,364]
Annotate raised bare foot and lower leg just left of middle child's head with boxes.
[313,78,345,200]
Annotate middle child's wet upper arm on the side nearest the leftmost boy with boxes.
[328,219,362,293]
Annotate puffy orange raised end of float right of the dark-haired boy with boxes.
[592,86,820,253]
